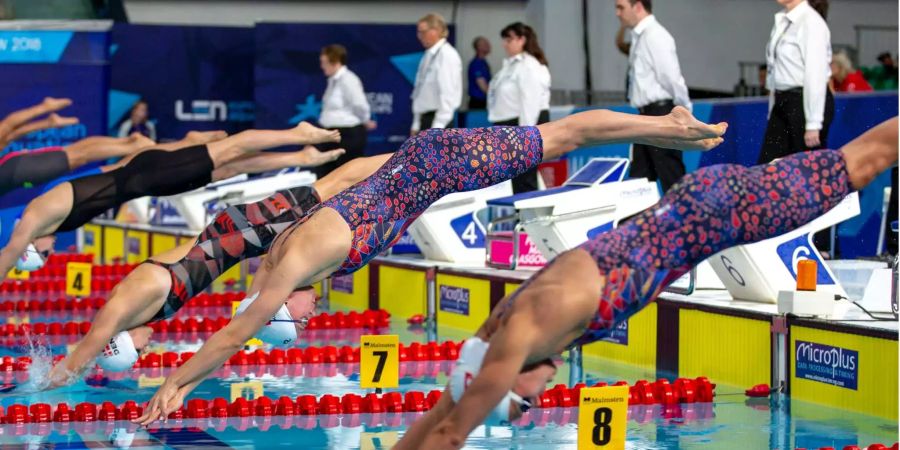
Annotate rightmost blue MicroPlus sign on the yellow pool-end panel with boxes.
[794,340,859,391]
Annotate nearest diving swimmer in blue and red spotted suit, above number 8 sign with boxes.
[394,118,897,450]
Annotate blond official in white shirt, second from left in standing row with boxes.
[410,14,462,134]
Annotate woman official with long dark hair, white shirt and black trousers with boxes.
[488,22,550,194]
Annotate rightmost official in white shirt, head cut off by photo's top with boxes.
[758,0,834,164]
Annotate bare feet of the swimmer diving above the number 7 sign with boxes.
[641,106,728,151]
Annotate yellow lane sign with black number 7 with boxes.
[359,334,400,388]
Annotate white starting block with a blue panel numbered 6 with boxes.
[708,192,859,303]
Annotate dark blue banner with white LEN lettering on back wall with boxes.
[106,24,256,141]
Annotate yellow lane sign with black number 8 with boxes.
[578,386,628,449]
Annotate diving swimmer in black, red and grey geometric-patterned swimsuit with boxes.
[49,155,390,388]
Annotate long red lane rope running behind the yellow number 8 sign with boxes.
[0,377,712,424]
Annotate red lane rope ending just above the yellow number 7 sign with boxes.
[0,309,391,337]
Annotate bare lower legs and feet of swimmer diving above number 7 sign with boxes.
[538,107,727,161]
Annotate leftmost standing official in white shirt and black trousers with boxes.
[316,44,375,177]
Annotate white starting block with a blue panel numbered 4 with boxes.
[408,181,512,265]
